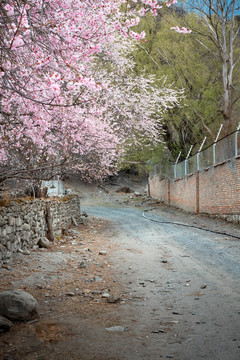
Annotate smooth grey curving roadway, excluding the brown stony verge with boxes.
[83,205,240,360]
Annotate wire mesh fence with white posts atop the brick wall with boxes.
[150,126,240,178]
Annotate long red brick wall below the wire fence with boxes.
[149,157,240,215]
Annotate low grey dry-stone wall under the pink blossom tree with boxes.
[0,195,80,267]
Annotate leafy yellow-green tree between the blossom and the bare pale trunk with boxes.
[131,8,222,159]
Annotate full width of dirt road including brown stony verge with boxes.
[0,181,240,360]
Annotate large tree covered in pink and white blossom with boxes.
[0,0,182,182]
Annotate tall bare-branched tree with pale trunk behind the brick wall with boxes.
[182,0,240,133]
